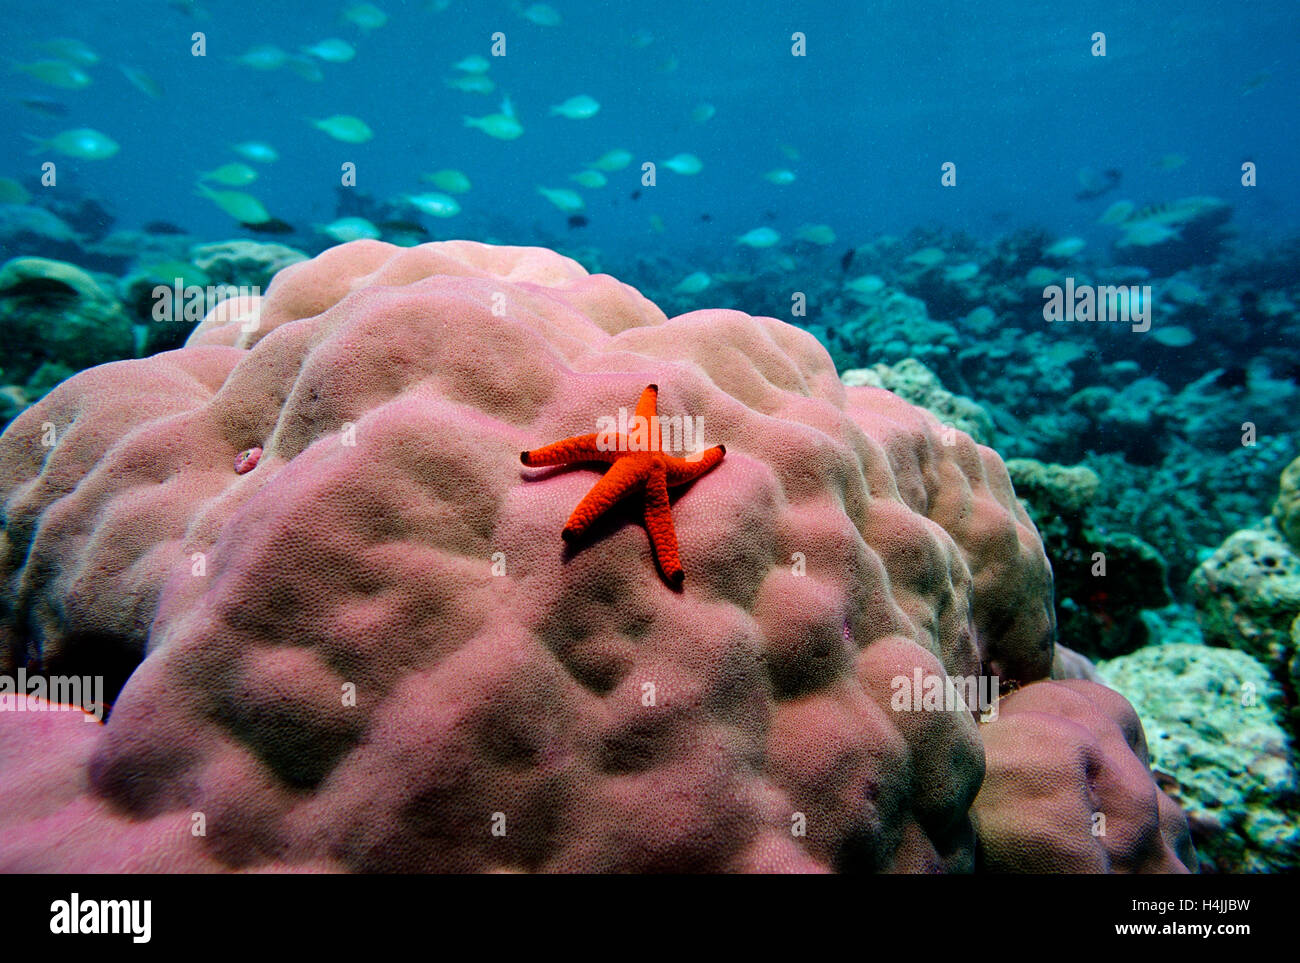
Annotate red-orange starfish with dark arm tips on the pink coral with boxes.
[519,385,727,587]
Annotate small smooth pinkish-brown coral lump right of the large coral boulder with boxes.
[974,680,1196,873]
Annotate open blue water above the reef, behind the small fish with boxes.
[0,0,1300,256]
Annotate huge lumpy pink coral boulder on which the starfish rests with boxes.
[0,242,1177,871]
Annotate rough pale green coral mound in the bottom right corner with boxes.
[1097,642,1300,873]
